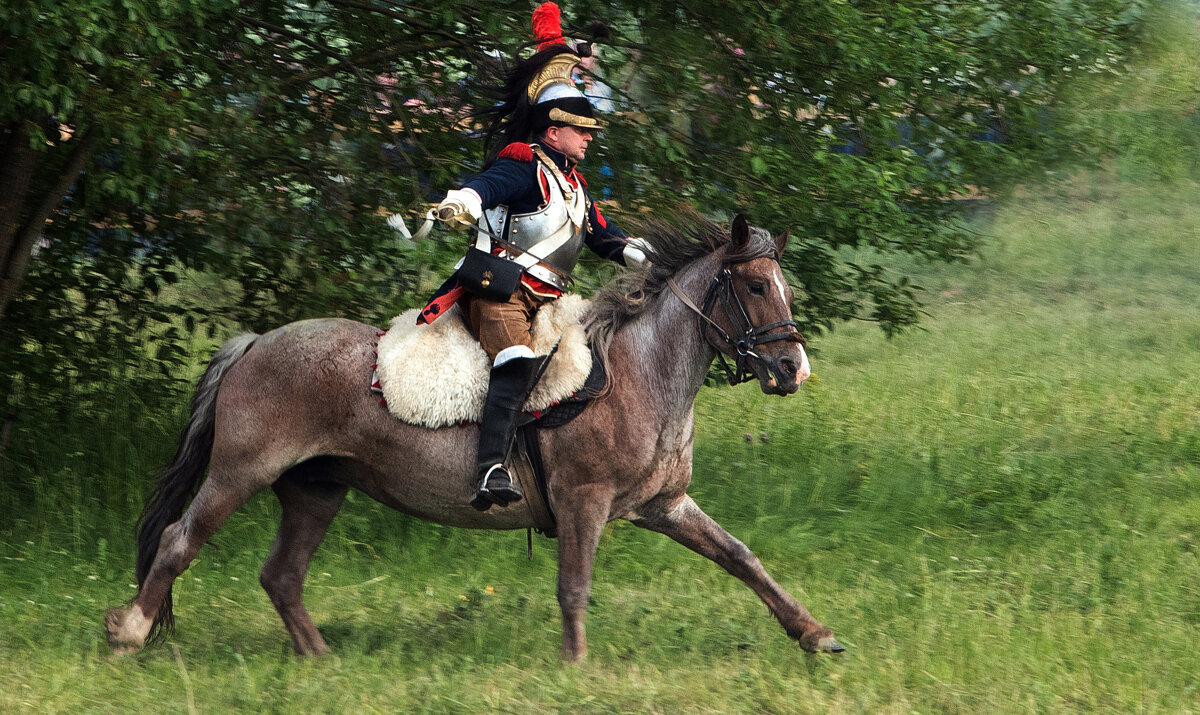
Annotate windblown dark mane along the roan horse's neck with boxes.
[584,209,776,371]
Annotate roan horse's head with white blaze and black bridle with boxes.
[703,215,811,395]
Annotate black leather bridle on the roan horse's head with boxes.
[666,257,805,385]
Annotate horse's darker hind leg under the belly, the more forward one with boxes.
[258,476,348,655]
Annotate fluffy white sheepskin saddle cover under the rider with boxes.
[376,295,592,428]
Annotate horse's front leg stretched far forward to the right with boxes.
[629,494,845,653]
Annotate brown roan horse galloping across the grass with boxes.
[106,215,842,661]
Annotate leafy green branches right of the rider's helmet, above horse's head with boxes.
[589,1,1141,334]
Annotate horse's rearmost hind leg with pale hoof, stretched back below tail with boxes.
[104,476,254,653]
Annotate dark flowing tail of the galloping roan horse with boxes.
[137,332,258,642]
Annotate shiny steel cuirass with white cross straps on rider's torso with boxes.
[475,148,588,290]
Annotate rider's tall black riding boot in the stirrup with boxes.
[470,358,545,511]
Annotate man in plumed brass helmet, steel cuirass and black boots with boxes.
[405,2,648,511]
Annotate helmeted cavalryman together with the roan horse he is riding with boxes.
[104,1,844,661]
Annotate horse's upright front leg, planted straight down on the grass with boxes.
[556,487,612,662]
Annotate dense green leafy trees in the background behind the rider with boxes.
[0,0,1151,475]
